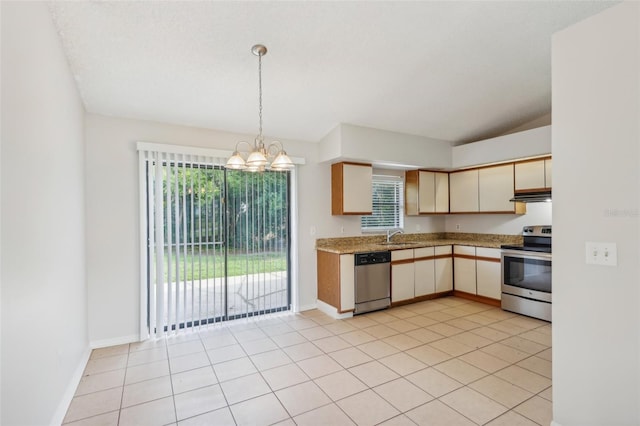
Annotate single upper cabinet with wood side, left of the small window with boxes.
[331,163,373,215]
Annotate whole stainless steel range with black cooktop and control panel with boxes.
[501,225,551,321]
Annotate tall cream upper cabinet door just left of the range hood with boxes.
[478,164,515,212]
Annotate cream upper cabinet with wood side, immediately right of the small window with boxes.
[405,170,449,216]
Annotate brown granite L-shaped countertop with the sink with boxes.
[316,232,522,254]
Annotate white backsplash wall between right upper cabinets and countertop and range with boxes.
[445,203,553,235]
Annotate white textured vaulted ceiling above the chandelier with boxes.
[51,1,613,142]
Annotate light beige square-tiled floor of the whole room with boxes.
[65,297,552,426]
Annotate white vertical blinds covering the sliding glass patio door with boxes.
[139,148,290,336]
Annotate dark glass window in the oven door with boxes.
[502,256,551,293]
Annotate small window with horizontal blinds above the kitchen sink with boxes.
[360,175,404,231]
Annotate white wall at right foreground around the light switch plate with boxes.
[552,2,640,426]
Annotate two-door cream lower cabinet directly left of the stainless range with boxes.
[453,246,502,300]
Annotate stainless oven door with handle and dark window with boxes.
[501,250,551,302]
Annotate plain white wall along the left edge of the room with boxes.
[0,2,89,425]
